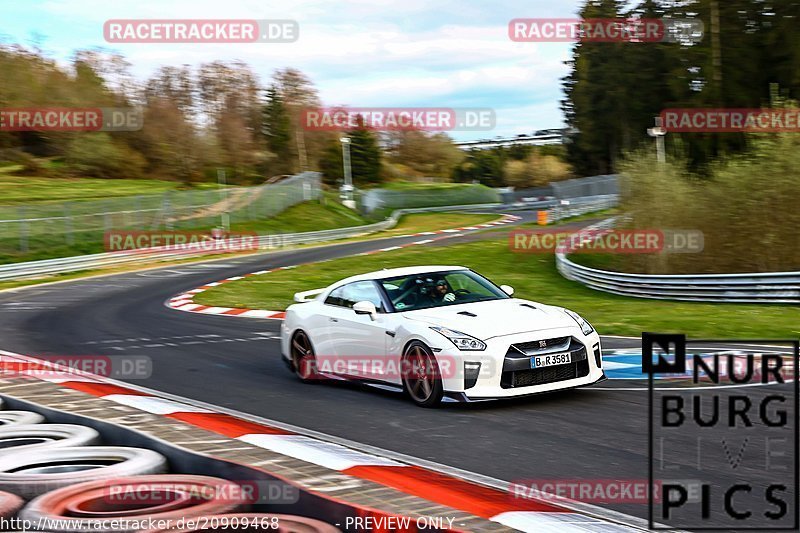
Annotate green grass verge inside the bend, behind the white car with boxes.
[195,239,800,338]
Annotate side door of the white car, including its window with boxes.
[328,280,388,380]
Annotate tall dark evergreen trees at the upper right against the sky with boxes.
[562,0,800,175]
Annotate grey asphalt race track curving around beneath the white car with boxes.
[0,210,796,517]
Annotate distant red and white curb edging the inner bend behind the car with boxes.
[165,214,522,320]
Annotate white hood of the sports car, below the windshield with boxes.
[402,298,577,340]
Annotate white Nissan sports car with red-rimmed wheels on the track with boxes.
[281,266,605,407]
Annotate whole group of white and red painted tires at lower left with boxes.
[0,399,339,533]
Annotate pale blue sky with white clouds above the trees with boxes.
[0,0,581,140]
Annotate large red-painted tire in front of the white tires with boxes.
[19,474,247,533]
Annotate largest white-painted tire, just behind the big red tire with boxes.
[0,446,167,500]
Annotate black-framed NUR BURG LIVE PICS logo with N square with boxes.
[642,333,800,531]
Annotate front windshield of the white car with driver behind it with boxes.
[379,270,509,311]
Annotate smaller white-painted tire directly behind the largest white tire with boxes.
[0,424,100,457]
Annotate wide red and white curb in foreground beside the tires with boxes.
[0,350,644,533]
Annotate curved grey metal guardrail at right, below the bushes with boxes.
[556,219,800,304]
